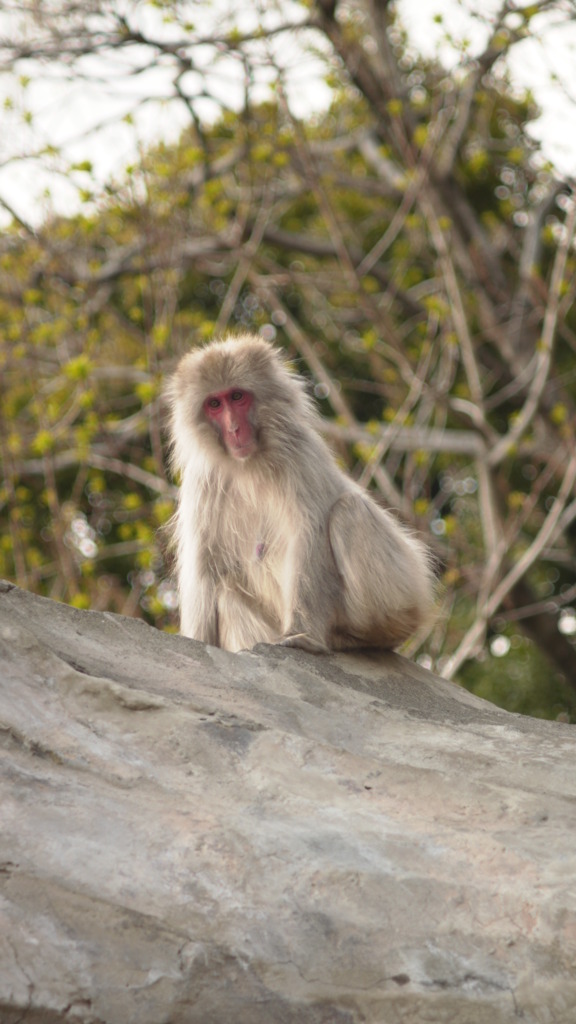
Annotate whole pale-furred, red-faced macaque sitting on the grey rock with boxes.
[168,335,434,652]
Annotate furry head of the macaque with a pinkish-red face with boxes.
[168,335,315,468]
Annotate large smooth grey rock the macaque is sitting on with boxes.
[0,585,576,1024]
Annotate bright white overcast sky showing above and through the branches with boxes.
[0,0,576,223]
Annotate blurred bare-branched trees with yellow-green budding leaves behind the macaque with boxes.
[0,0,576,720]
